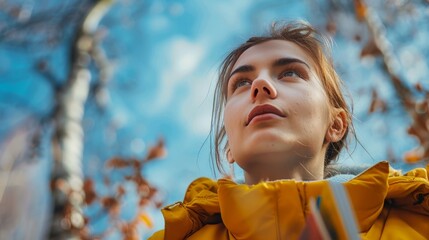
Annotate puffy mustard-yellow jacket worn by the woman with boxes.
[150,162,429,240]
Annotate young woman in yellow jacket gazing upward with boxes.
[151,22,429,240]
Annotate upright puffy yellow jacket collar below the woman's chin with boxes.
[218,162,389,239]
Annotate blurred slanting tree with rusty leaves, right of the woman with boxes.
[324,0,429,163]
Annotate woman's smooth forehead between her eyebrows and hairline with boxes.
[232,40,314,71]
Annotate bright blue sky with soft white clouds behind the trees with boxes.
[0,0,429,239]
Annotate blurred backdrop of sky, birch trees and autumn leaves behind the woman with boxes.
[0,0,429,239]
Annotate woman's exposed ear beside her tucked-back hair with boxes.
[325,108,348,142]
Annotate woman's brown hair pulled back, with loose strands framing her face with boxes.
[210,21,353,173]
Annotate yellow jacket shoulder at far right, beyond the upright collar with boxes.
[368,165,429,239]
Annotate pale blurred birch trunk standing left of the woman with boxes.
[49,0,113,239]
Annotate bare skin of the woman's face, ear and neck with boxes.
[224,40,346,184]
